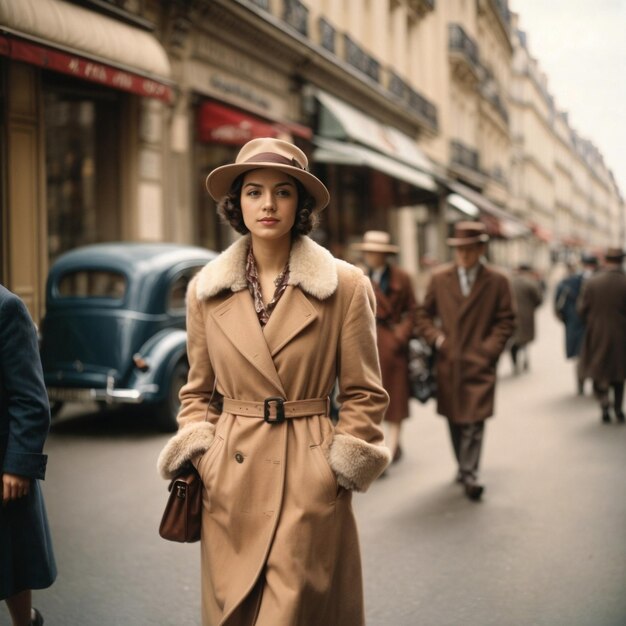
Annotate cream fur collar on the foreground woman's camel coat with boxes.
[196,235,338,300]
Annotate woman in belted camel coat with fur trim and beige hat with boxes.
[159,139,390,626]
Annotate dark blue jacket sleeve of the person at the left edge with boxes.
[0,292,50,479]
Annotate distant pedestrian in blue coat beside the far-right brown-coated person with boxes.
[554,254,598,395]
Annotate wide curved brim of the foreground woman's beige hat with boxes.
[206,161,330,211]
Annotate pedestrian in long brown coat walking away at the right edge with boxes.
[578,248,626,424]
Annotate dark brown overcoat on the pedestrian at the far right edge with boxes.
[578,269,626,383]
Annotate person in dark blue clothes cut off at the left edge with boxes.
[0,285,57,626]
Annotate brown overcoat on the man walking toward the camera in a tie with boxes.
[418,264,515,424]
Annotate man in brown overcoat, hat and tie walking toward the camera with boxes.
[418,222,515,500]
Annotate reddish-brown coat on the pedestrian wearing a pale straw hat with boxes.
[373,265,417,422]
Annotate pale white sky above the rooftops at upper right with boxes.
[509,0,626,198]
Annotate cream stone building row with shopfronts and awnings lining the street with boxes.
[0,0,624,319]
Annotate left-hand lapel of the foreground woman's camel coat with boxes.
[211,290,287,397]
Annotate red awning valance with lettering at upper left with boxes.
[0,33,173,102]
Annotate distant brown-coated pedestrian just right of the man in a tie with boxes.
[509,263,543,374]
